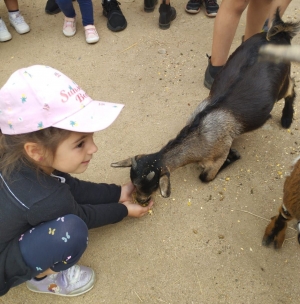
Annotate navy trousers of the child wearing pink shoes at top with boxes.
[56,0,94,26]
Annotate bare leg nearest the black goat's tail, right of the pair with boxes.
[244,0,273,41]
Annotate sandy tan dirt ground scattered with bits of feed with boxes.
[0,0,300,304]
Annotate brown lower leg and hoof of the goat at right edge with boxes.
[262,212,289,249]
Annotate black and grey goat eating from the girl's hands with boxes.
[111,10,300,204]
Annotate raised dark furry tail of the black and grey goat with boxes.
[267,7,300,41]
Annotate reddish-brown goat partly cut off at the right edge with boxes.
[262,157,300,249]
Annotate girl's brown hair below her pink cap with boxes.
[0,127,71,177]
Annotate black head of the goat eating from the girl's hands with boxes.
[111,153,171,205]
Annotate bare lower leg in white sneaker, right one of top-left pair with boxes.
[4,0,30,34]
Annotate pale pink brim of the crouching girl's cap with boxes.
[52,100,124,133]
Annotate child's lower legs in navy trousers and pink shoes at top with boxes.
[56,0,99,43]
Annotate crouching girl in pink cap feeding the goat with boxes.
[0,65,153,296]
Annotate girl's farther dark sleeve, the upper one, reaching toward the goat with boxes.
[58,172,121,205]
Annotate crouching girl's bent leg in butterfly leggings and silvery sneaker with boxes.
[19,214,95,296]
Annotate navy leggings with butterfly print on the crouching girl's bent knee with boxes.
[19,214,88,276]
